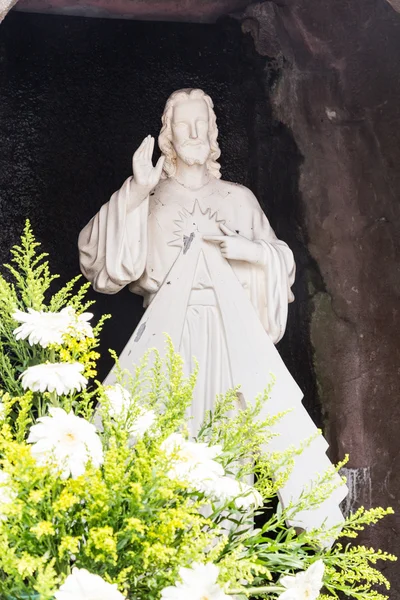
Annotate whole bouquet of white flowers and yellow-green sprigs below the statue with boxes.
[0,223,395,600]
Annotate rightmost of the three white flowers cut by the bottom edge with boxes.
[279,560,325,600]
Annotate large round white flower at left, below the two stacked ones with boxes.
[27,408,103,479]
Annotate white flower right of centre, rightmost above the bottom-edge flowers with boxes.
[202,477,263,510]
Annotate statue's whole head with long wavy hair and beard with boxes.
[158,89,221,178]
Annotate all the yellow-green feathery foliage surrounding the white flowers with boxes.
[0,223,395,600]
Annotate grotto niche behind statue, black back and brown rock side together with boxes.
[0,0,400,598]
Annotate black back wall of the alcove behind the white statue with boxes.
[0,9,320,424]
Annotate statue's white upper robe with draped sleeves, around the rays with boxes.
[79,177,295,344]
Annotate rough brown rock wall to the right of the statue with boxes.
[243,0,400,599]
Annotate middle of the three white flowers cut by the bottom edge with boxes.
[161,563,231,600]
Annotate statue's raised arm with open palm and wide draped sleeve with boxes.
[78,136,164,294]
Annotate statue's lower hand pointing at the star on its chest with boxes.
[203,224,263,264]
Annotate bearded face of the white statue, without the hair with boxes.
[171,99,210,165]
